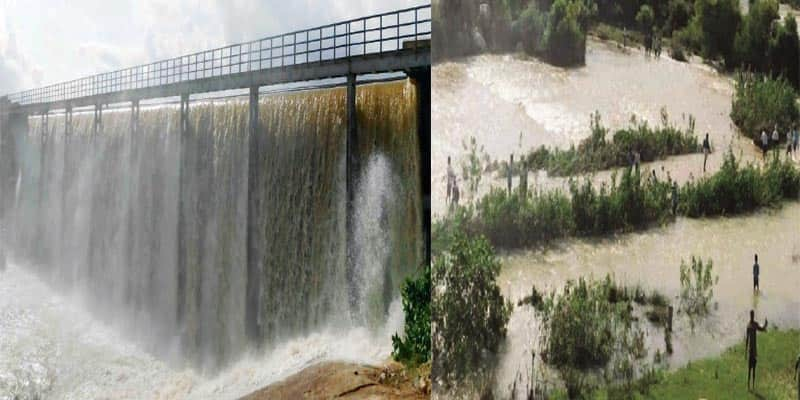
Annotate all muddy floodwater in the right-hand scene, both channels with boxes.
[431,39,800,398]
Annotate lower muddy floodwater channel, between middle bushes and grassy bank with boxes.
[497,202,800,398]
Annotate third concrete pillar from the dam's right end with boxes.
[245,86,266,345]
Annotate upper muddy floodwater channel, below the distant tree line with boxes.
[431,40,761,216]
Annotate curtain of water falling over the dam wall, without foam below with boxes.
[0,82,423,396]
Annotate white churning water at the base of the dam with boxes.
[0,263,403,400]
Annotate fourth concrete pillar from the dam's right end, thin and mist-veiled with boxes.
[176,94,189,325]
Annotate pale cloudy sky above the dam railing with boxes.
[0,0,430,96]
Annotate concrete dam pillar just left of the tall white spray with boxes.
[345,74,359,310]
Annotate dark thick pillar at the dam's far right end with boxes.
[411,67,431,263]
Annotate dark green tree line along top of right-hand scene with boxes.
[433,0,800,88]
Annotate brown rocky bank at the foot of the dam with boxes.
[242,362,431,400]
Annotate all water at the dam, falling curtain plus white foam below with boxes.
[0,81,423,399]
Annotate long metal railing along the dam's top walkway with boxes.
[1,5,431,105]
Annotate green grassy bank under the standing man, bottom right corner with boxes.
[624,327,800,399]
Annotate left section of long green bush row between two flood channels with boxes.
[460,165,670,248]
